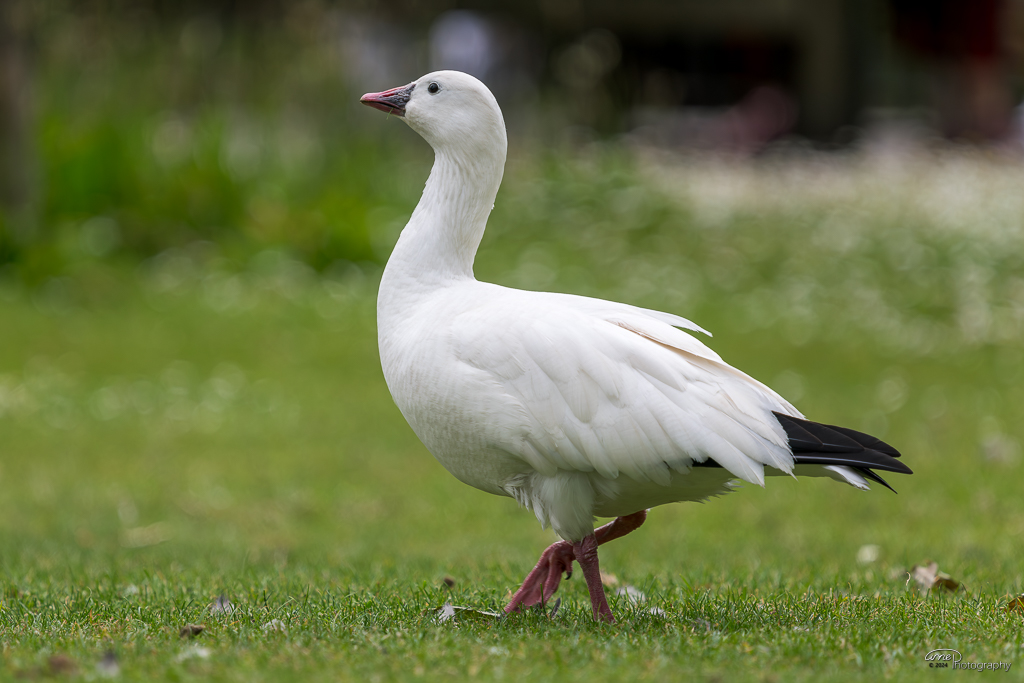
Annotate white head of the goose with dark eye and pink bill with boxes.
[359,71,508,161]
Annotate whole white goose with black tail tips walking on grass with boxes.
[360,71,910,622]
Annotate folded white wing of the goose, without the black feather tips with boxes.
[453,290,800,485]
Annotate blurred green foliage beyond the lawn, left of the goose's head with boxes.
[0,5,428,282]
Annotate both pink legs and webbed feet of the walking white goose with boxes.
[505,510,647,621]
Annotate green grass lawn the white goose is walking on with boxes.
[0,151,1024,681]
